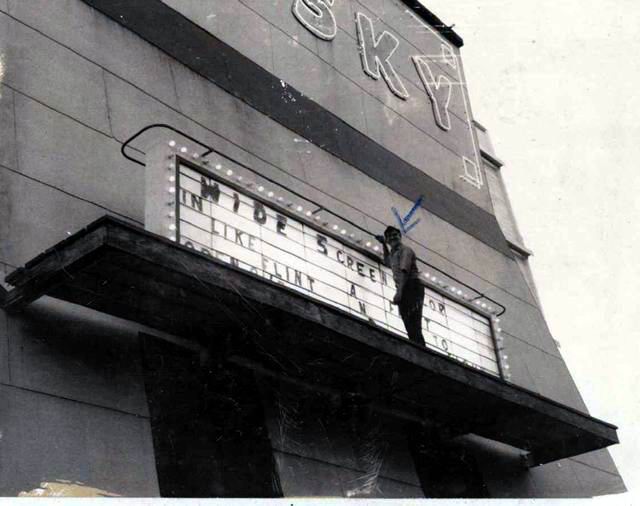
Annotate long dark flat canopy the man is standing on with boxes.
[4,217,618,464]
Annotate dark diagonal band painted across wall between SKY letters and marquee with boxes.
[83,0,513,257]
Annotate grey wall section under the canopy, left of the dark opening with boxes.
[0,298,158,497]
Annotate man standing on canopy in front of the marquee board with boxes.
[376,226,424,346]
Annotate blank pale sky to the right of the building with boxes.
[424,0,640,500]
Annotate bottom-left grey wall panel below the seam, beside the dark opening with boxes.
[0,386,158,497]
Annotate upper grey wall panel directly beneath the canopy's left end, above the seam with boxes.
[8,298,148,416]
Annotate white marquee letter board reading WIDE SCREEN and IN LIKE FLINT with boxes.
[147,146,499,375]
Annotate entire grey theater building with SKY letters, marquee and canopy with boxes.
[0,0,625,498]
